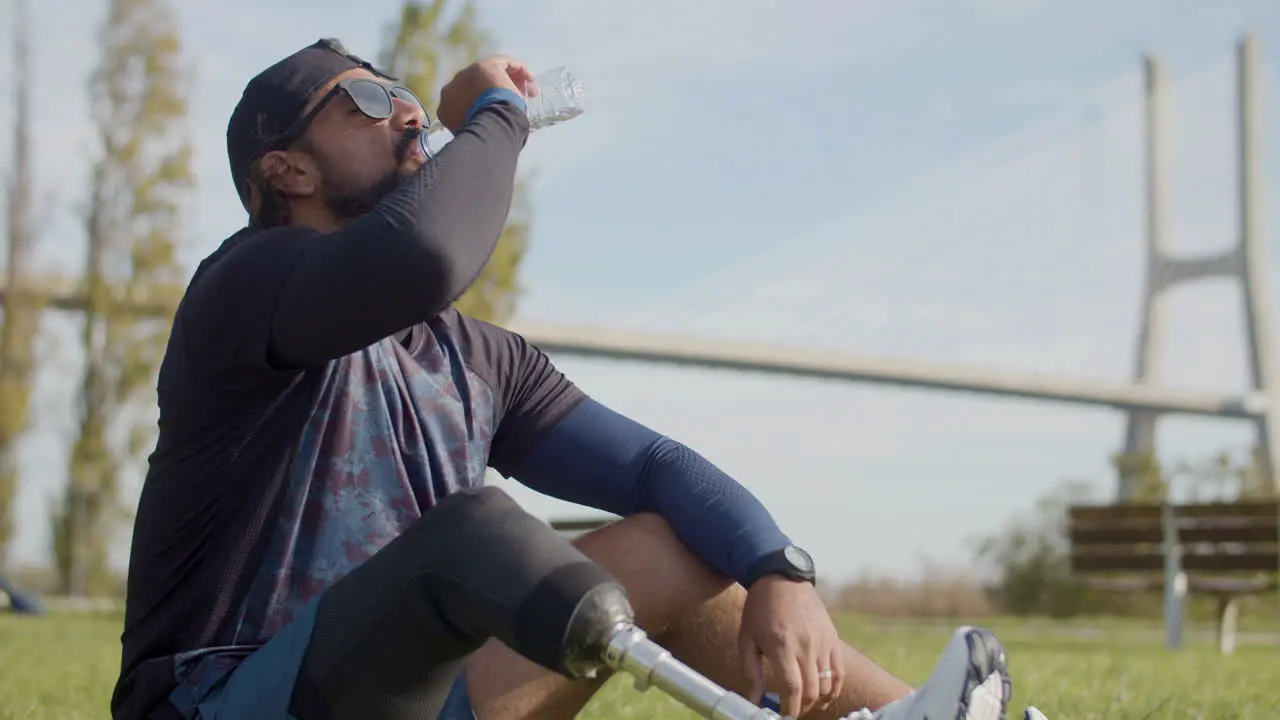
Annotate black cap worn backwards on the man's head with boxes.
[227,38,388,210]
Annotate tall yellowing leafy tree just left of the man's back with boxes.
[54,0,195,594]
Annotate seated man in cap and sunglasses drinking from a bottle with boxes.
[111,40,1039,720]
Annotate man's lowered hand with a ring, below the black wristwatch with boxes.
[739,575,845,717]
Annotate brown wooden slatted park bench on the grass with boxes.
[1068,500,1280,655]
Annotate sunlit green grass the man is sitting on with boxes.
[0,615,1280,720]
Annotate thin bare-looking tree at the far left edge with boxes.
[0,0,44,573]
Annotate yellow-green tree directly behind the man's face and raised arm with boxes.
[379,0,531,324]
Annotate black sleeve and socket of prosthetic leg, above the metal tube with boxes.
[291,488,632,720]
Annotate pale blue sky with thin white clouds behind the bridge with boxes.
[0,0,1280,580]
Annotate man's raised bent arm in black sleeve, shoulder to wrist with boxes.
[269,99,529,366]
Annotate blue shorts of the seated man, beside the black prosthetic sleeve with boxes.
[172,598,476,720]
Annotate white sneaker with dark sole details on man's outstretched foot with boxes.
[845,626,1008,720]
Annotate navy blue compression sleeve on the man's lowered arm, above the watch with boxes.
[517,398,791,582]
